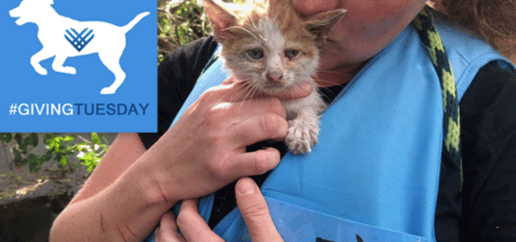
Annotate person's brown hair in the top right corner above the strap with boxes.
[435,0,516,61]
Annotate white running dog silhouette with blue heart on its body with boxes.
[9,0,150,94]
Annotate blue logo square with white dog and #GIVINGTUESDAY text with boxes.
[0,0,157,132]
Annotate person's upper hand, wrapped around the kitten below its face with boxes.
[141,78,311,205]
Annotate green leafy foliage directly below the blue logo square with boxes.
[0,133,108,172]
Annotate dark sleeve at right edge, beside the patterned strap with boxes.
[459,63,516,241]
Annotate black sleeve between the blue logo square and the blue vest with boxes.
[139,36,217,149]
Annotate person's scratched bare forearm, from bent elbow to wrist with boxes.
[50,156,177,241]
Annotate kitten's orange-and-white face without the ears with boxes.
[221,18,319,94]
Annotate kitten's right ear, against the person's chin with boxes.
[303,9,347,47]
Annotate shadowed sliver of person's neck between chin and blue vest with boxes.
[314,61,367,87]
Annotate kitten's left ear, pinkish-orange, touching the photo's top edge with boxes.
[203,0,237,42]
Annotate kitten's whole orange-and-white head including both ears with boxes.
[205,0,343,95]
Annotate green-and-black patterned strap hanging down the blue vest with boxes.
[413,9,464,191]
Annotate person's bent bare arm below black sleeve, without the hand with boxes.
[50,134,175,241]
